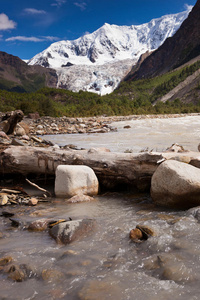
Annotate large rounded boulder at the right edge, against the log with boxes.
[151,160,200,209]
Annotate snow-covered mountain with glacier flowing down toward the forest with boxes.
[28,8,190,94]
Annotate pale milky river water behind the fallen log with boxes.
[46,115,200,152]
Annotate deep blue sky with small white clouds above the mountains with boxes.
[0,0,196,59]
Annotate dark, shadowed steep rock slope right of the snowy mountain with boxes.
[130,0,200,80]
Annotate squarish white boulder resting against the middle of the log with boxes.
[55,165,99,197]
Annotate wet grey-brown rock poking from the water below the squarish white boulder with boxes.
[49,219,95,244]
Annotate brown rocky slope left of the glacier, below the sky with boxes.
[0,51,57,92]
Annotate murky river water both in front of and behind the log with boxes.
[0,116,200,300]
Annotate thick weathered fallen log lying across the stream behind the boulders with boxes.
[0,146,200,190]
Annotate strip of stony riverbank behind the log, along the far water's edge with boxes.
[0,113,199,148]
